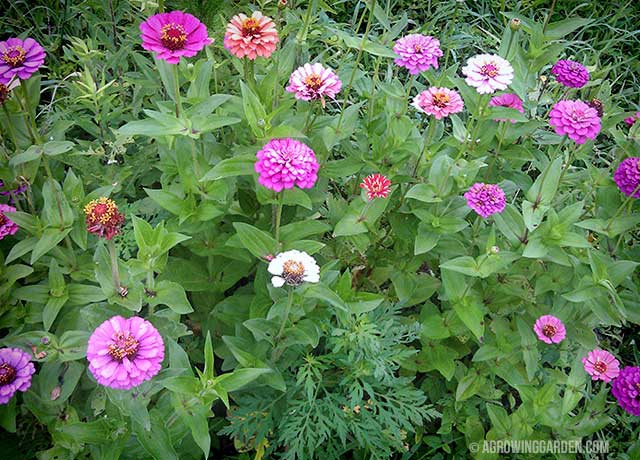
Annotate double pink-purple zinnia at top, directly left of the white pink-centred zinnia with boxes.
[393,34,442,75]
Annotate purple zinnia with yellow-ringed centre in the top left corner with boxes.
[0,38,45,84]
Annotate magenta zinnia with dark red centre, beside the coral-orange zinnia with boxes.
[140,11,213,64]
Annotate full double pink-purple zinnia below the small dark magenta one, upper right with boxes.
[549,100,600,144]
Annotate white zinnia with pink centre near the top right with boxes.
[462,54,513,94]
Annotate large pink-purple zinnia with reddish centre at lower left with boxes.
[87,316,164,390]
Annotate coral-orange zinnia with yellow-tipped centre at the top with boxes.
[224,11,280,60]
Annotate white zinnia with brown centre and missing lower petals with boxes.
[268,249,320,287]
